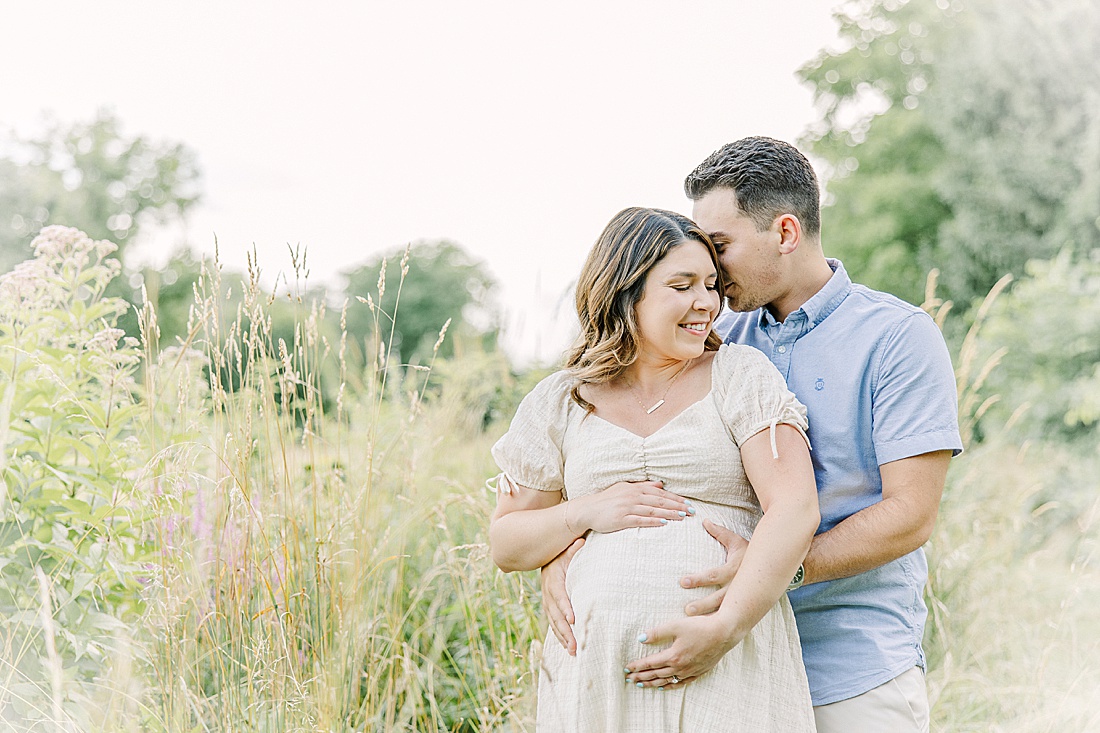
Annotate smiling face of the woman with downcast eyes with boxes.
[635,239,721,360]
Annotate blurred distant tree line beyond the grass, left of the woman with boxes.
[0,111,498,372]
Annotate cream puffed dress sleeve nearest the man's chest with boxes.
[713,343,810,458]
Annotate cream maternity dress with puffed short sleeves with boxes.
[493,344,814,733]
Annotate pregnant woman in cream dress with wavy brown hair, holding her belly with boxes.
[490,208,818,733]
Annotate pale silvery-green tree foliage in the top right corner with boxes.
[928,0,1100,303]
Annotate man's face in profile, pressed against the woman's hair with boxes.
[692,188,781,313]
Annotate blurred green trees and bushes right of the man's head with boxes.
[800,0,1100,444]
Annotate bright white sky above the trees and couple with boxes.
[0,0,836,361]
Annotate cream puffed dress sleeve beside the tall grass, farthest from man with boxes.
[492,372,572,493]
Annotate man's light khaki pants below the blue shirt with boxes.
[814,667,928,733]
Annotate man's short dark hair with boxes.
[684,138,821,238]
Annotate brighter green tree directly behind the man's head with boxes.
[800,0,963,303]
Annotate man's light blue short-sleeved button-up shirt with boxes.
[717,260,963,705]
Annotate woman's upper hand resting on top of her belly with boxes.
[565,481,695,534]
